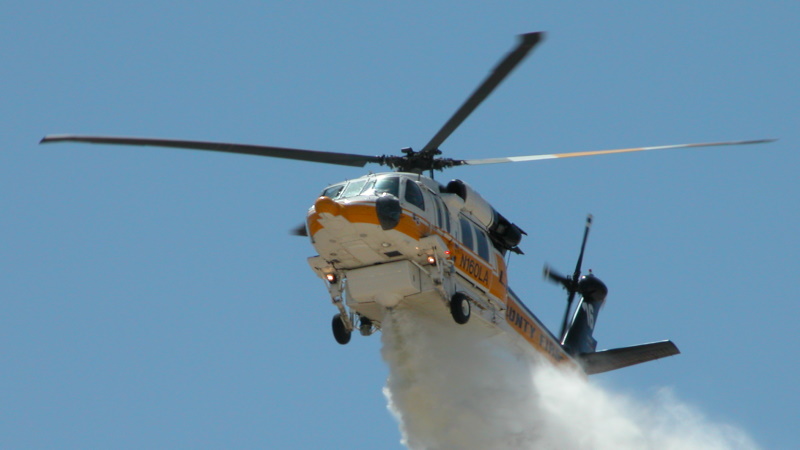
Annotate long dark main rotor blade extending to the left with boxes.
[39,135,384,167]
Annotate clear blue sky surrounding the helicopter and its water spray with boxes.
[0,1,800,448]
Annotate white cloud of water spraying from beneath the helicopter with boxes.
[382,309,757,450]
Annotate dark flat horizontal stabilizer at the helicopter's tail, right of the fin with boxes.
[578,341,680,375]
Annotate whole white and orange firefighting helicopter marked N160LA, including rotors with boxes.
[41,32,772,375]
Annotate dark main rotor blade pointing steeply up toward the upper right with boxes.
[421,32,544,152]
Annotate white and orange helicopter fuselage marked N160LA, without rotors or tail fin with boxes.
[306,172,574,363]
